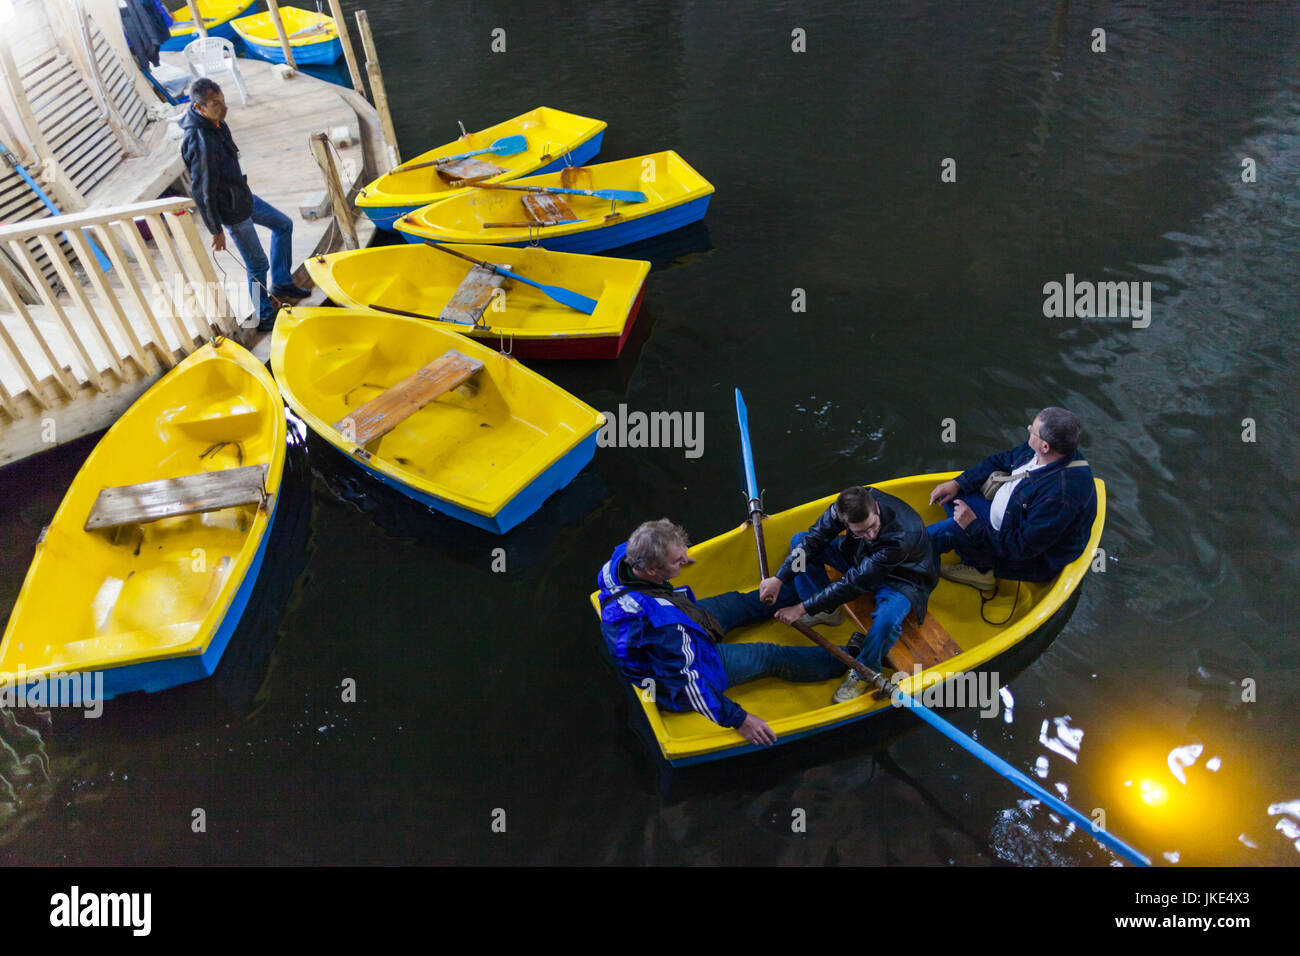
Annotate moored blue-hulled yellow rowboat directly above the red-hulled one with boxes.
[397,150,714,254]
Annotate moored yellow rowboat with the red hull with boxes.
[307,243,650,359]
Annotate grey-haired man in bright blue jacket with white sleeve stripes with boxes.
[597,518,861,747]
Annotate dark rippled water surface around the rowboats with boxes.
[0,0,1300,865]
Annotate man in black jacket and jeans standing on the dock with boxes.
[181,78,309,332]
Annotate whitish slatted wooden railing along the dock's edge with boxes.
[0,198,247,420]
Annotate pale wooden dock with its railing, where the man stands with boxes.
[0,20,389,466]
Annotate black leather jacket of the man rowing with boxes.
[776,488,939,624]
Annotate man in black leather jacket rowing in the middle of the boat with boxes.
[758,485,939,704]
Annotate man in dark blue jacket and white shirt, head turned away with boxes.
[926,406,1097,591]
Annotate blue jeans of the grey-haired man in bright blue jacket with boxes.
[698,585,844,687]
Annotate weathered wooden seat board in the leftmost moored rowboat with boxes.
[86,464,267,531]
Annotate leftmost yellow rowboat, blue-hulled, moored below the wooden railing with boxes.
[0,339,285,698]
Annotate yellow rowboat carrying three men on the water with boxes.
[592,472,1106,766]
